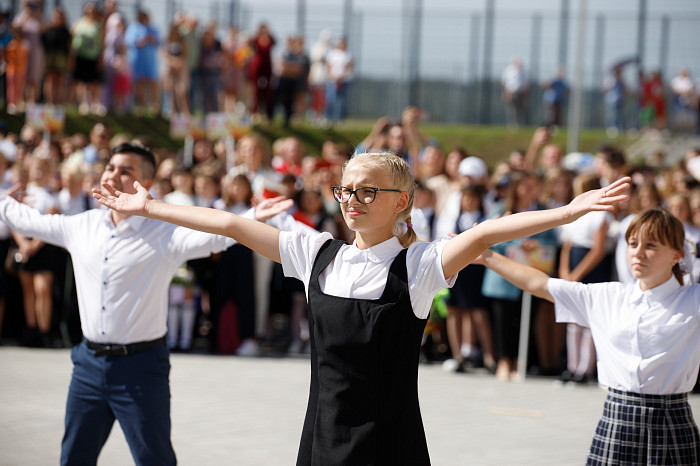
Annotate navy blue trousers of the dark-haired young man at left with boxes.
[61,341,177,465]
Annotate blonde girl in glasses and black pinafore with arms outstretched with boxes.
[93,153,627,465]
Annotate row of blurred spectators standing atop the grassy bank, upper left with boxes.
[0,0,353,125]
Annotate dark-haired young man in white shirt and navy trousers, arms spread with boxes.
[0,143,245,465]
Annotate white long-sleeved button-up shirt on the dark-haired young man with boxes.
[0,197,235,344]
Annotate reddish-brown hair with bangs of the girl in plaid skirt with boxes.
[625,207,685,285]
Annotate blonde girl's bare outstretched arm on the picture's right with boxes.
[442,177,630,278]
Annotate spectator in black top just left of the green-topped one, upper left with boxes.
[41,6,71,105]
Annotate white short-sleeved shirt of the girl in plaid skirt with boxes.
[547,276,700,395]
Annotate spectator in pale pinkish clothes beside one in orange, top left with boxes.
[12,0,45,110]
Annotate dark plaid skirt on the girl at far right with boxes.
[586,388,700,466]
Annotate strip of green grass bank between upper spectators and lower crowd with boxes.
[0,110,631,167]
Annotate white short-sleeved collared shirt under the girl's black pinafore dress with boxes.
[279,231,457,319]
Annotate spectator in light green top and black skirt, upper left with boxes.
[71,2,105,115]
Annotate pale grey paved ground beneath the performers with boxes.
[0,347,700,466]
